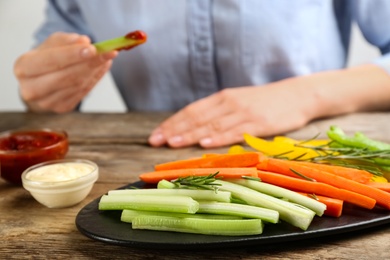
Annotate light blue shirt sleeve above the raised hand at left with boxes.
[34,0,92,45]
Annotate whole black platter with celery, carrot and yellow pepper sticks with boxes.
[76,127,390,249]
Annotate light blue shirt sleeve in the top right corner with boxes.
[350,0,390,74]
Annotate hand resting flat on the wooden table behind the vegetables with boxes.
[149,77,313,148]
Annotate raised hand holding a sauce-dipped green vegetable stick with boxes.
[14,32,117,113]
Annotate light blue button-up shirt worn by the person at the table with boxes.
[36,0,390,111]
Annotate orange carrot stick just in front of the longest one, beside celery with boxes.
[257,171,376,209]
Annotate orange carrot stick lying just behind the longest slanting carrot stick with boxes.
[299,162,373,184]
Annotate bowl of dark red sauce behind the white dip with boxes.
[0,129,69,185]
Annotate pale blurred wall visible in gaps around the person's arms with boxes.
[0,0,379,112]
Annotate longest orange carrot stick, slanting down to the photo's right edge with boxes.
[259,158,390,210]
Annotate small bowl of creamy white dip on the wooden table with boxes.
[22,159,99,208]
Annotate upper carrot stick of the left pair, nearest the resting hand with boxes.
[154,153,260,171]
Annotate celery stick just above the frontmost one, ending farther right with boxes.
[197,201,279,223]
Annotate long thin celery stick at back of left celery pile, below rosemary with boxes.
[108,189,231,202]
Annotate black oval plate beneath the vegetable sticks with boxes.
[76,182,390,250]
